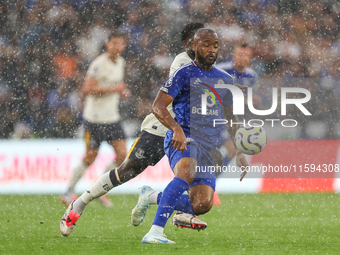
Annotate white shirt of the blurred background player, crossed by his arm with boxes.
[83,53,125,124]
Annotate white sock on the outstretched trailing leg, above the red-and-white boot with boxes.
[80,170,114,204]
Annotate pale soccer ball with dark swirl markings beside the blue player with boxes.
[235,127,267,155]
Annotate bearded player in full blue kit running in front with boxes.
[142,28,248,244]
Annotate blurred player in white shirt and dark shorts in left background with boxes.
[60,33,130,207]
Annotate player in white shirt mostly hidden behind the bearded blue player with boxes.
[60,23,207,236]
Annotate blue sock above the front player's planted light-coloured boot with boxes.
[152,177,189,228]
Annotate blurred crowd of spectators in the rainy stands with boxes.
[0,0,340,139]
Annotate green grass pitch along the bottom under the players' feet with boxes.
[0,194,340,255]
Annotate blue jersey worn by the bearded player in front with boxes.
[161,61,234,148]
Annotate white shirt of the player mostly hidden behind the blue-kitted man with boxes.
[141,52,192,137]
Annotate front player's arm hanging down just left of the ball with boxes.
[224,105,249,181]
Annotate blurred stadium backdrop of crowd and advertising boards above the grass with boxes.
[0,0,340,193]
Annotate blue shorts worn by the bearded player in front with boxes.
[164,130,216,190]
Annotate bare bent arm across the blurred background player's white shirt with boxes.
[82,76,126,96]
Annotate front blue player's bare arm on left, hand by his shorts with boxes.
[152,91,187,153]
